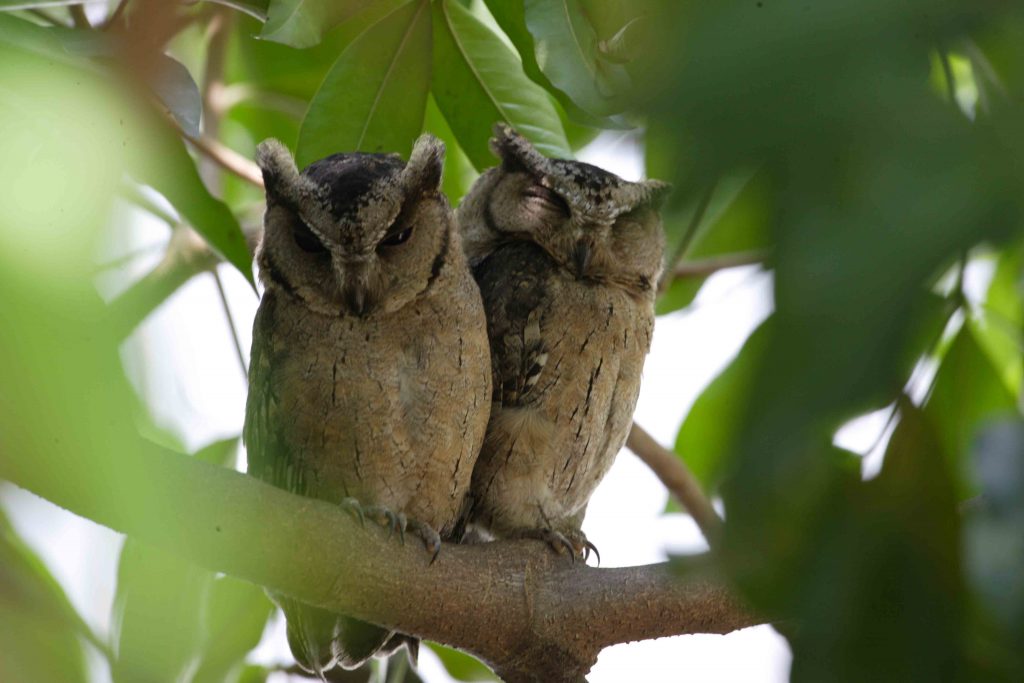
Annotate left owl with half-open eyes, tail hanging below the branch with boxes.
[244,135,492,677]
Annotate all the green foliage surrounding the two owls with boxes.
[0,0,1024,681]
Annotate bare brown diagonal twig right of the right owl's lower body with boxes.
[626,422,722,548]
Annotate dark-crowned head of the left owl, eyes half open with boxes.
[256,135,454,316]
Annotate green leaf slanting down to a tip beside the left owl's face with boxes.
[125,116,255,286]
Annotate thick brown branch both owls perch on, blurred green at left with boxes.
[0,439,759,683]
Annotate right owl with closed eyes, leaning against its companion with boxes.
[457,126,668,560]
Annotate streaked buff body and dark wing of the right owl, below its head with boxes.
[472,246,653,536]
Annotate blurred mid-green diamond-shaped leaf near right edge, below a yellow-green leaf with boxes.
[925,325,1016,496]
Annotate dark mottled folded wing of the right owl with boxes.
[474,242,553,407]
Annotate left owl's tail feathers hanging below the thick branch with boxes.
[272,594,403,680]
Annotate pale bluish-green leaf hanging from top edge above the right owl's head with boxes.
[524,0,631,116]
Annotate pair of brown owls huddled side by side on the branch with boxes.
[245,126,666,674]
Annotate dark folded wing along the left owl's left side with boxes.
[242,294,305,495]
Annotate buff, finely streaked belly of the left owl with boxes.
[264,278,489,538]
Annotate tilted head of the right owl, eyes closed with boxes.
[459,124,669,295]
